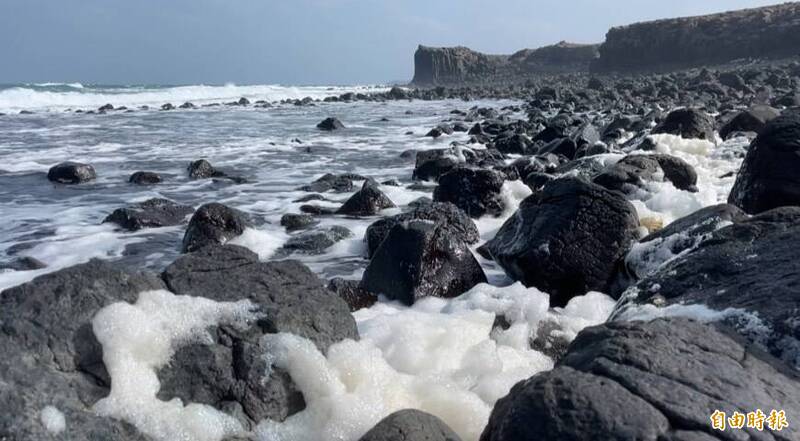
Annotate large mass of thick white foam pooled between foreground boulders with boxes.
[256,284,614,441]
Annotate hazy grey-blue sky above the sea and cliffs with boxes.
[0,0,779,84]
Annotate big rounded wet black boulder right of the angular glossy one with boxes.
[488,178,639,305]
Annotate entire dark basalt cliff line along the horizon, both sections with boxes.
[412,2,800,86]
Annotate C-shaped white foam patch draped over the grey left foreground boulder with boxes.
[92,290,254,441]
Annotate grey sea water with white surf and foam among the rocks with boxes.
[0,84,747,440]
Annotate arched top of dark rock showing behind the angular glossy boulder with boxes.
[364,202,480,258]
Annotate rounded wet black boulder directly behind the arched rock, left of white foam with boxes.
[433,167,505,218]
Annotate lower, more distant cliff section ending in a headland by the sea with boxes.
[412,42,598,85]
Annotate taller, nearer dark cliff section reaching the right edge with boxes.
[592,3,800,73]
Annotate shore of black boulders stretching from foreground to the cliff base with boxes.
[0,50,800,441]
